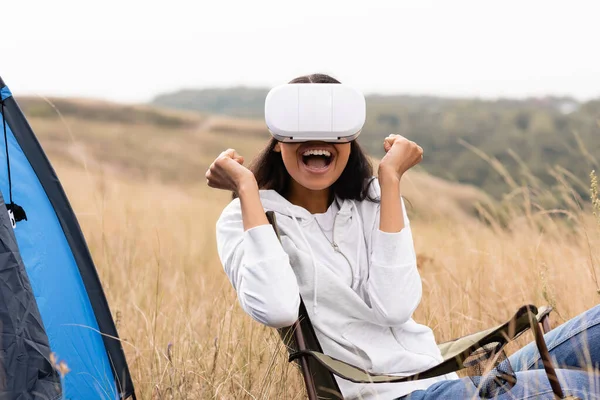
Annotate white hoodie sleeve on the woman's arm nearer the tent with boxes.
[217,199,300,328]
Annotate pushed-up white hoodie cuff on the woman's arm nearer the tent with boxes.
[243,225,287,265]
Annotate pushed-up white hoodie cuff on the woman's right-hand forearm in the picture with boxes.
[372,226,416,267]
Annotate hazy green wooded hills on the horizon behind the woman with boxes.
[152,87,600,197]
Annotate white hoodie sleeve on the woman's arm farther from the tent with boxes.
[367,180,423,326]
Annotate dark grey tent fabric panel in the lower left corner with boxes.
[0,190,62,400]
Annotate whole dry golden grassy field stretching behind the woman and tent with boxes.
[26,100,600,399]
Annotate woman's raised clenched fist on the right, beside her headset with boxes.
[379,135,423,179]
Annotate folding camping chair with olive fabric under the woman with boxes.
[267,211,579,400]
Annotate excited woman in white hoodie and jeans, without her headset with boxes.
[206,74,600,400]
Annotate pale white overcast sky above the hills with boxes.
[0,0,600,102]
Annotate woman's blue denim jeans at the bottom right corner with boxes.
[401,305,600,400]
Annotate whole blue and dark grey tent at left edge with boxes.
[0,78,135,400]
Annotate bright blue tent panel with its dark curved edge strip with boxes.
[0,79,135,400]
